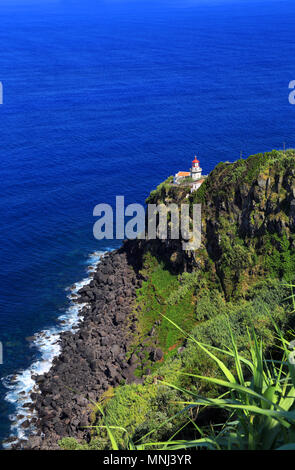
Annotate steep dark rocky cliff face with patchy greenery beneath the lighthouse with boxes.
[148,150,295,299]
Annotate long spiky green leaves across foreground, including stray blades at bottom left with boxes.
[60,286,295,450]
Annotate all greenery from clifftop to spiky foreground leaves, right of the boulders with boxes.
[61,150,295,449]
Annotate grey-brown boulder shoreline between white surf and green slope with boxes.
[12,243,141,450]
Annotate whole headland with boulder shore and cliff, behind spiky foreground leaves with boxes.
[19,150,295,448]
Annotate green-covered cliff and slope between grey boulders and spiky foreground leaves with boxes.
[75,150,295,448]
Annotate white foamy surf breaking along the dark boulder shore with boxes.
[2,251,107,448]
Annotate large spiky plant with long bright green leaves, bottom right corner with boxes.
[158,319,295,450]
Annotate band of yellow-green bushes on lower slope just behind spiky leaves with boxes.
[61,280,292,449]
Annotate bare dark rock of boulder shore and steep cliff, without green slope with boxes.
[14,150,295,449]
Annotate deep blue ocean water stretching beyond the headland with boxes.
[0,0,295,448]
